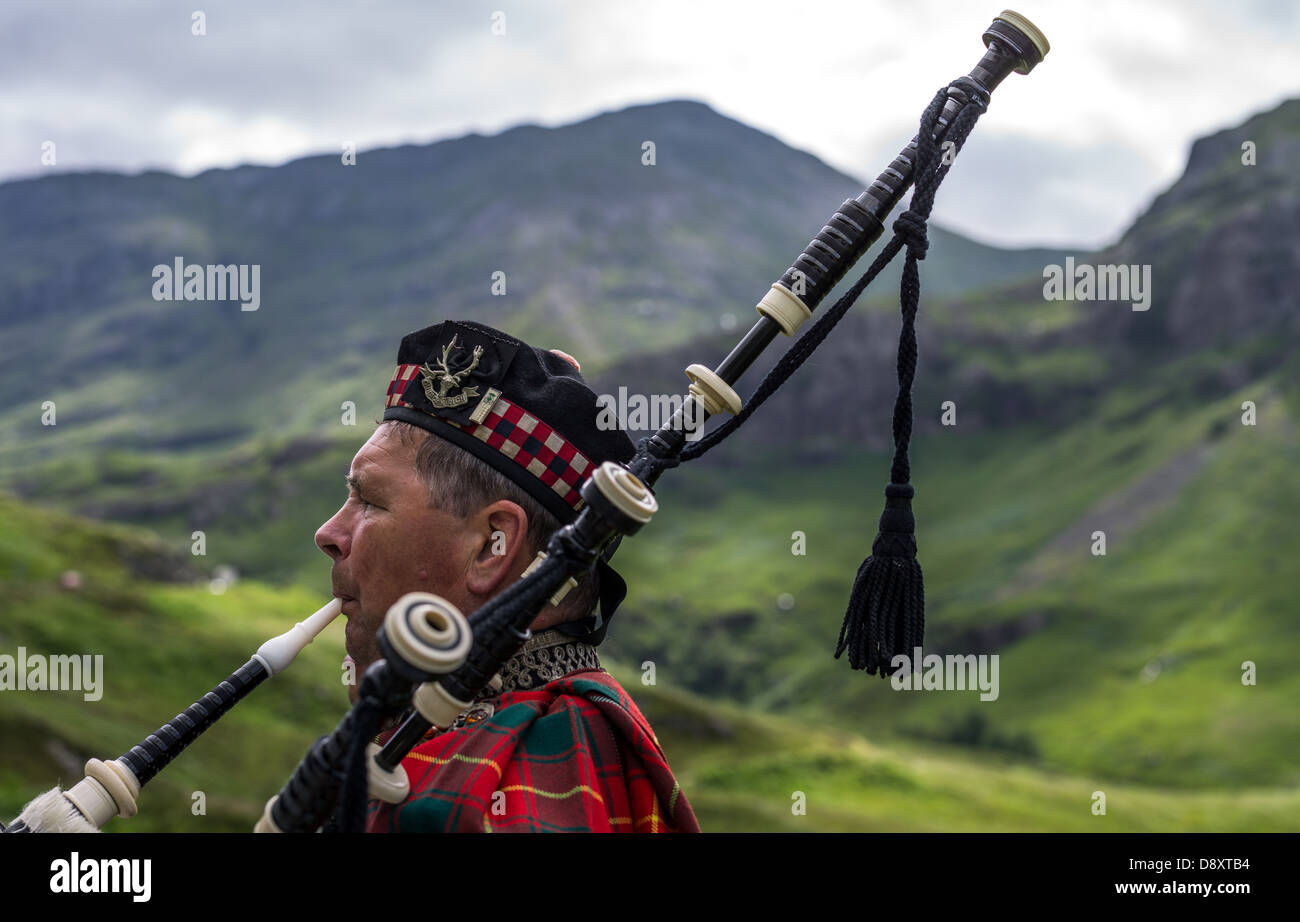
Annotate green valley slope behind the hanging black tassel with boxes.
[610,345,1300,788]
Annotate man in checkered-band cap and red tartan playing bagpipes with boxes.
[316,321,699,832]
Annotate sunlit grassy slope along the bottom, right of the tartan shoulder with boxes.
[612,667,1300,832]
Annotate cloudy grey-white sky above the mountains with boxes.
[0,0,1300,247]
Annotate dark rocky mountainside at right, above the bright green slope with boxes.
[601,100,1300,456]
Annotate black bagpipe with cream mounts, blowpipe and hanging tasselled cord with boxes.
[5,10,1049,832]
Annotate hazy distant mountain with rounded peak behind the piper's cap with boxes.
[0,100,1058,485]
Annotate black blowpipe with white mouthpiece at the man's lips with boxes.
[5,598,342,832]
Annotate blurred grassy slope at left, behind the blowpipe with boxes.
[0,494,346,831]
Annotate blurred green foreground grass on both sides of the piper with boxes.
[0,494,1300,832]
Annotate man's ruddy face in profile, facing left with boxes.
[316,425,477,701]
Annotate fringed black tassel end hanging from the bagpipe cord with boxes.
[835,484,926,678]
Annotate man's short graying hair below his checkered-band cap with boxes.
[382,420,598,620]
